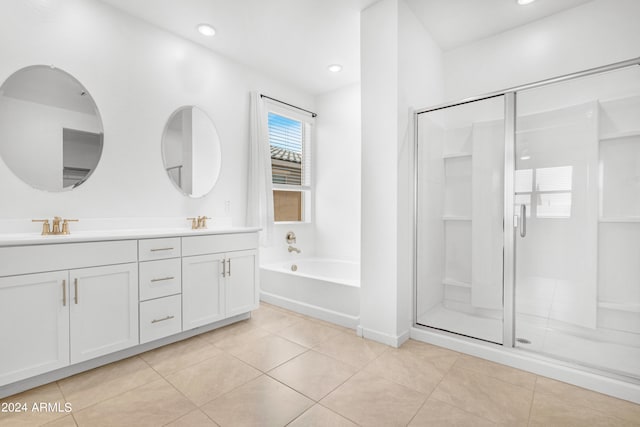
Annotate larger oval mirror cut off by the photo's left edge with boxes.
[0,65,104,191]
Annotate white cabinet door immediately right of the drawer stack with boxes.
[182,254,225,331]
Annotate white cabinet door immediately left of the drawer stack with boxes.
[69,263,138,363]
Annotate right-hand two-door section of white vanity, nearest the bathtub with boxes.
[182,233,259,330]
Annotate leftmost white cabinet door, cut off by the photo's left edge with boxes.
[0,271,69,386]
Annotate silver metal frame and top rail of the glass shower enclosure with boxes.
[412,57,640,348]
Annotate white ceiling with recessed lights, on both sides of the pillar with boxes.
[102,0,590,94]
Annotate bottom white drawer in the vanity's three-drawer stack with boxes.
[140,295,182,344]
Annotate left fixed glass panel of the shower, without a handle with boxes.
[416,95,505,343]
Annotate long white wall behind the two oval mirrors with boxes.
[0,0,314,226]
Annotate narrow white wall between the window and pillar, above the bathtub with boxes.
[314,84,361,261]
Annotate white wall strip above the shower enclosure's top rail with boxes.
[442,0,640,101]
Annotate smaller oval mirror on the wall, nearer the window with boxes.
[162,106,221,197]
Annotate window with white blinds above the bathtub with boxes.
[268,106,312,222]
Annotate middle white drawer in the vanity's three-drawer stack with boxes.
[140,258,182,301]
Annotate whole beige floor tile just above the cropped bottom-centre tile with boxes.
[269,350,357,401]
